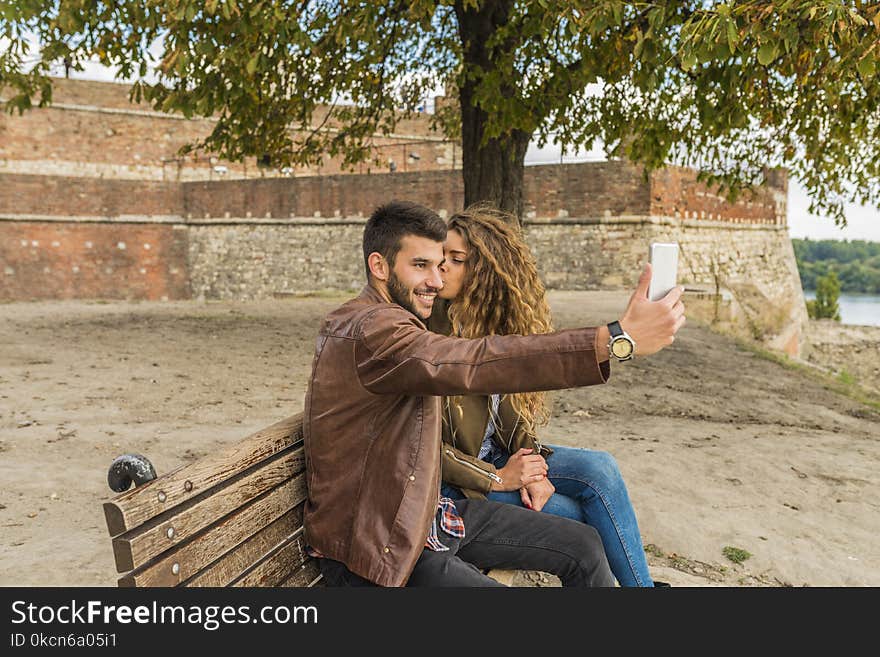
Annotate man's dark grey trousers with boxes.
[321,500,614,586]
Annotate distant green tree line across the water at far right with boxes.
[791,239,880,294]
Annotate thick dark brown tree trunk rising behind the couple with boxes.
[456,0,531,223]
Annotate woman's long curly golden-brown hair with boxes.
[447,205,553,431]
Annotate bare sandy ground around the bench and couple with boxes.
[0,292,880,586]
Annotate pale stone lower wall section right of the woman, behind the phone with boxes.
[526,219,808,355]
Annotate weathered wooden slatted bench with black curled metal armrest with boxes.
[104,413,321,587]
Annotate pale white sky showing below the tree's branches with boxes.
[12,57,880,242]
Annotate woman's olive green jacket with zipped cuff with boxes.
[428,299,552,498]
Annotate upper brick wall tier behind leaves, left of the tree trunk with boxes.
[0,79,461,181]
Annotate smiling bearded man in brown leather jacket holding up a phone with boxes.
[303,202,684,586]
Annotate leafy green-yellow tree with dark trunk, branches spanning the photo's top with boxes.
[0,0,880,224]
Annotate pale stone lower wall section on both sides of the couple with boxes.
[179,218,807,355]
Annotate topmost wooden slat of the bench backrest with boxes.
[104,413,302,536]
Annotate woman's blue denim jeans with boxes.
[443,445,654,586]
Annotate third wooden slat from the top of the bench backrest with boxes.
[113,473,306,586]
